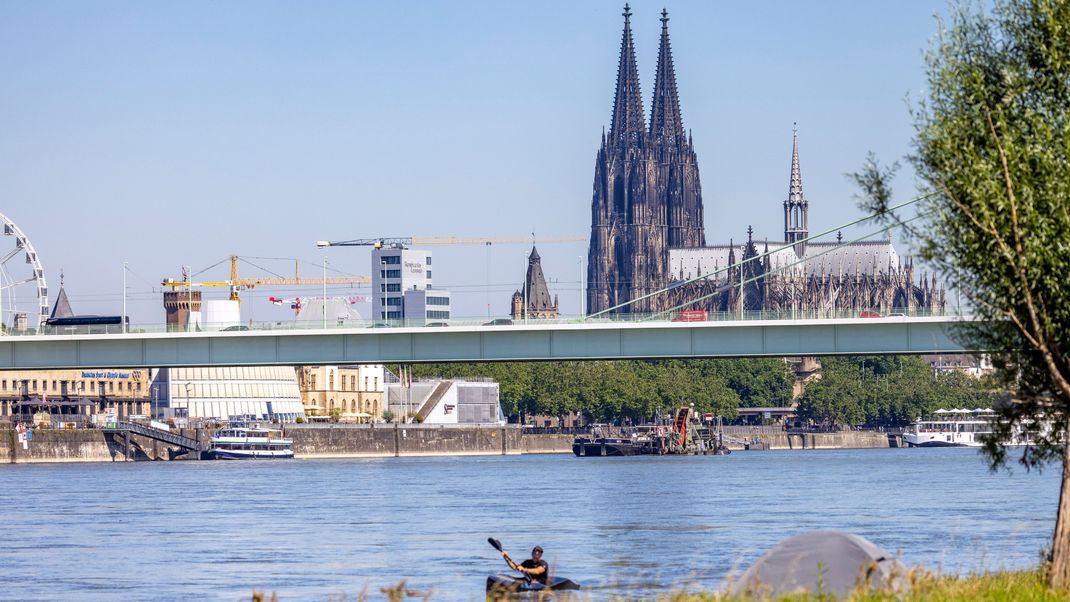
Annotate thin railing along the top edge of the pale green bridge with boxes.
[3,308,949,336]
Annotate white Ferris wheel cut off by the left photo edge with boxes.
[0,213,48,334]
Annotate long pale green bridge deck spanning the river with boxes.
[0,315,982,370]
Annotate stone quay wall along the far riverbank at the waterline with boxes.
[0,425,888,464]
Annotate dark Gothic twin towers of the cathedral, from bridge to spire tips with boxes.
[587,5,706,312]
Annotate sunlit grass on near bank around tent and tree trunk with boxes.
[662,570,1070,602]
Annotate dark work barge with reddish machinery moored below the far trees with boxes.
[572,407,749,457]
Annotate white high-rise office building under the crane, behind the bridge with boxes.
[371,247,449,325]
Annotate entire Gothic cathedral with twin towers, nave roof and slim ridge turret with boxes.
[587,4,946,314]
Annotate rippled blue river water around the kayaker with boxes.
[0,449,1059,601]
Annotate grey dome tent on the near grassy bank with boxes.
[730,530,907,598]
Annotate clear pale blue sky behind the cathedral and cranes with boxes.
[0,0,946,324]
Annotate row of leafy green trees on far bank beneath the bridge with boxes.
[404,356,993,426]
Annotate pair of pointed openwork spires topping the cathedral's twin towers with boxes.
[609,4,686,148]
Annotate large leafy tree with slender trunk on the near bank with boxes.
[894,0,1070,589]
